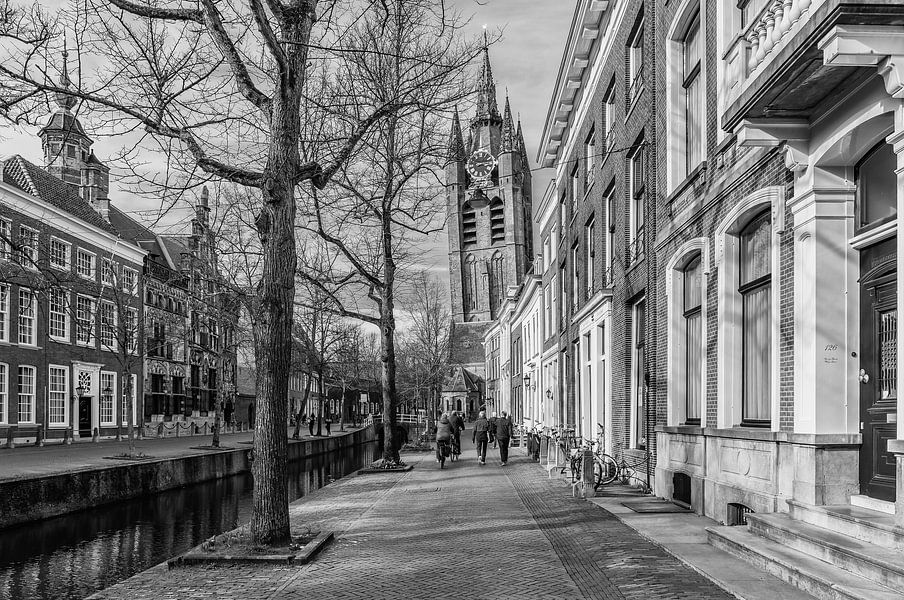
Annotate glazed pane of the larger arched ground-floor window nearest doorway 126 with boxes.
[738,210,772,426]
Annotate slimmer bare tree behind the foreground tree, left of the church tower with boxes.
[299,0,480,463]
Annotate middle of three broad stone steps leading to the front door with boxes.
[747,513,904,595]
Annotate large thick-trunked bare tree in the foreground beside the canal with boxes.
[0,0,452,545]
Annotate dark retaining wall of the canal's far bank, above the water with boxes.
[0,427,376,528]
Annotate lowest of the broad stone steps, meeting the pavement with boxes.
[706,515,901,600]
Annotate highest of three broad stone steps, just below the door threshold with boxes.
[788,500,904,551]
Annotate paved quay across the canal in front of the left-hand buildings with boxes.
[0,427,355,481]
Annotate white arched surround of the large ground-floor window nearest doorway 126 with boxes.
[715,185,785,431]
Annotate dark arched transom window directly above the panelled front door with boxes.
[855,140,897,228]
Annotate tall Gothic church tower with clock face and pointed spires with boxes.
[446,47,533,373]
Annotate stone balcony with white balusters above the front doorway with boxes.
[720,0,904,131]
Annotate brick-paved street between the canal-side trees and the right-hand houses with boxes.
[92,436,731,600]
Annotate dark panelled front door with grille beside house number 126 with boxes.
[859,238,898,502]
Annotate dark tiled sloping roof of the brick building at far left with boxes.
[2,154,119,235]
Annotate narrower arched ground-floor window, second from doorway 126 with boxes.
[682,254,703,425]
